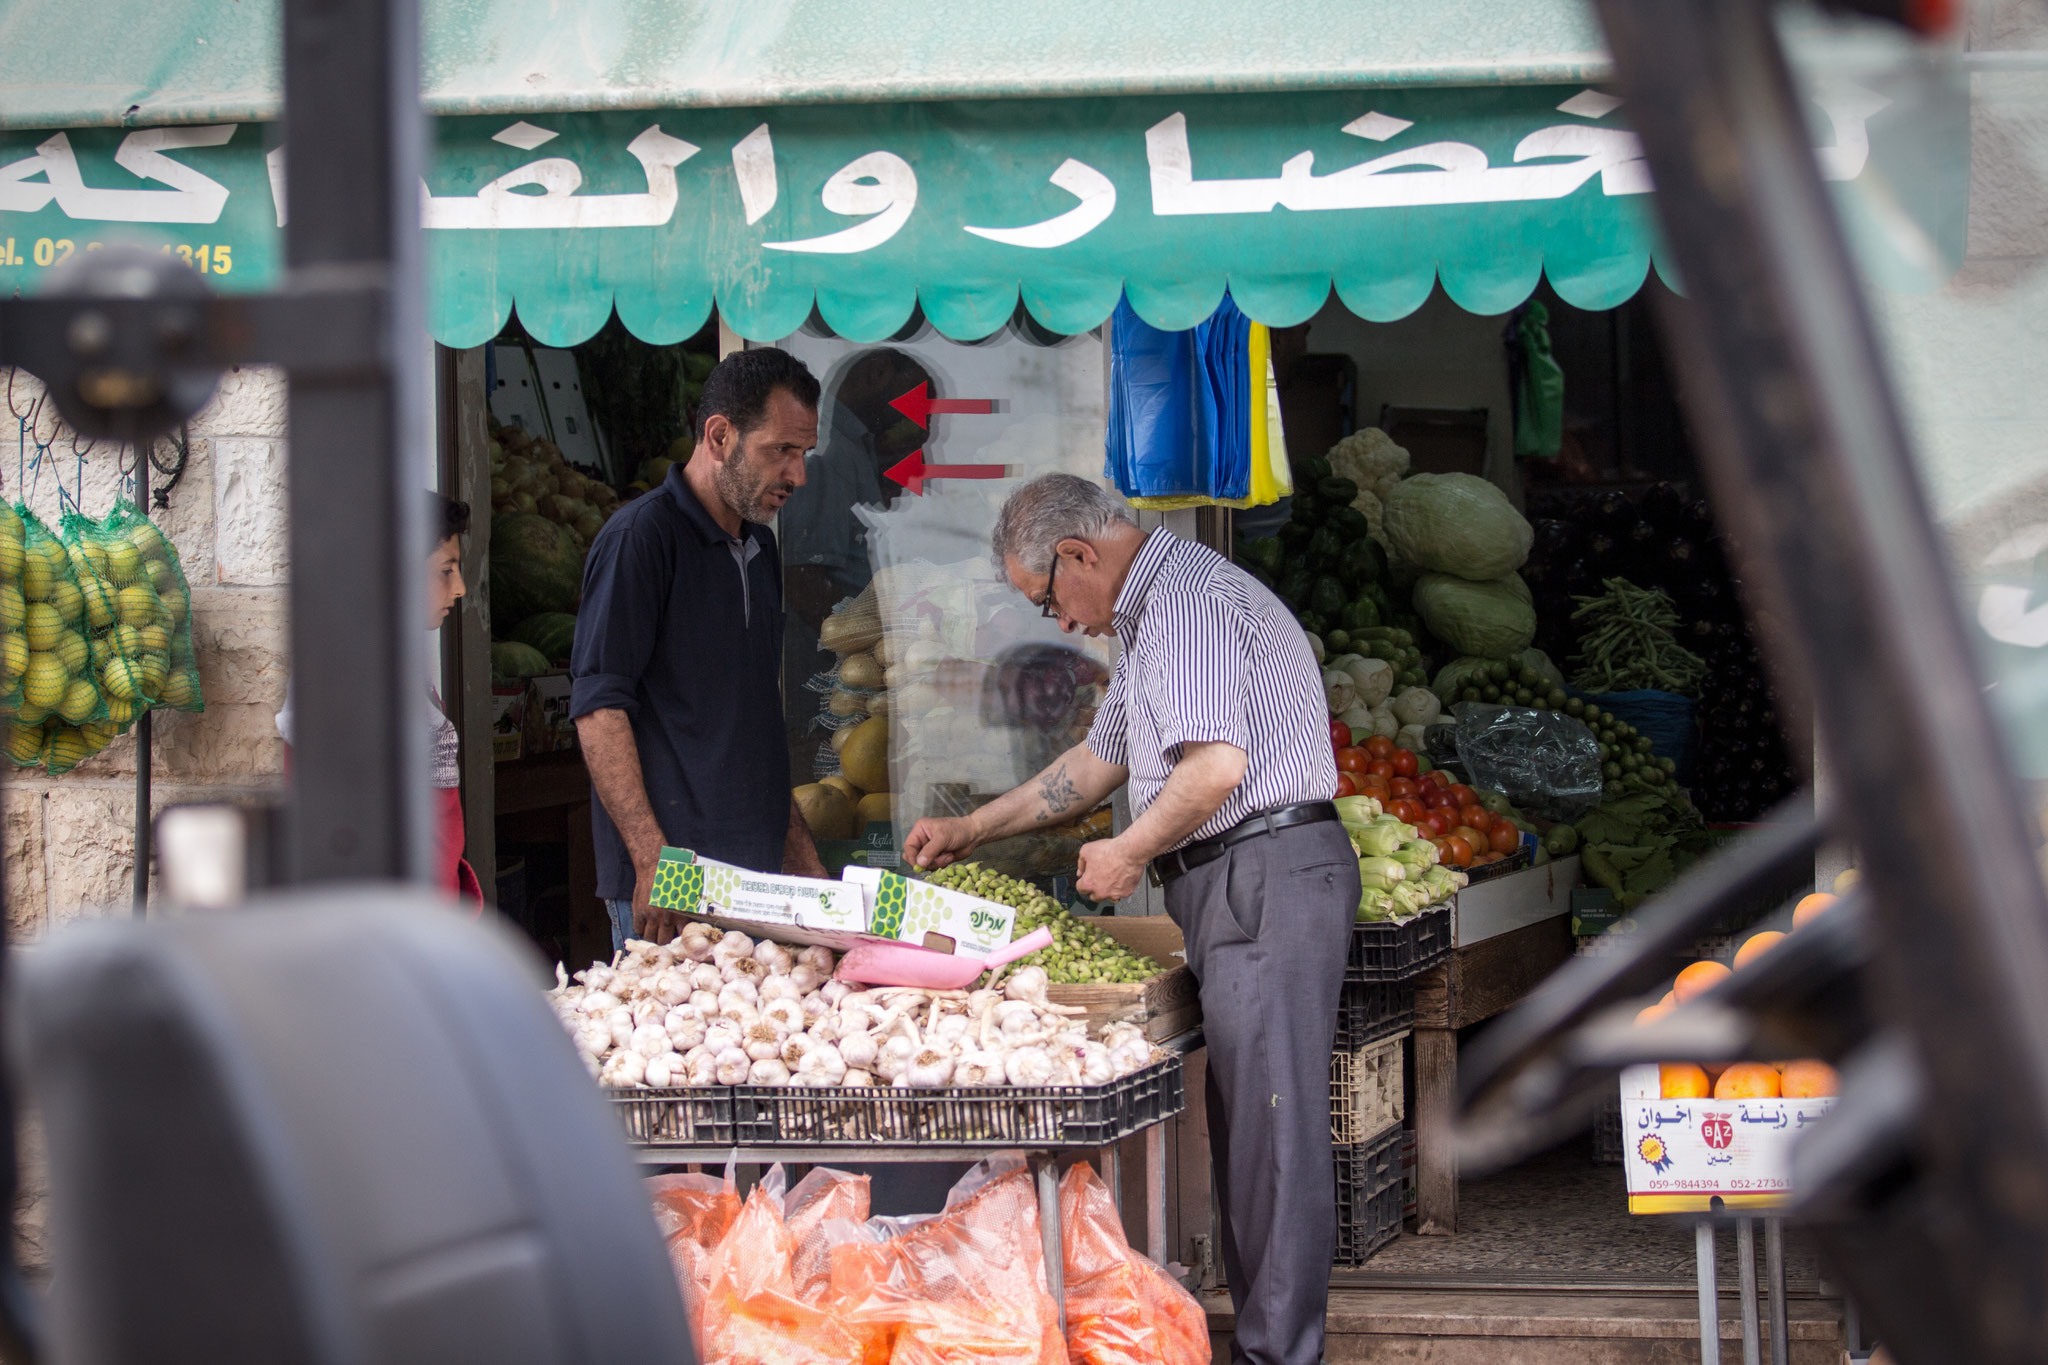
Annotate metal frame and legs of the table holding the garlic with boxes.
[631,1029,1202,1330]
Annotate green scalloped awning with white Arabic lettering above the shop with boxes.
[0,0,1968,346]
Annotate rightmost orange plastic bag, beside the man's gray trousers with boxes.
[1059,1160,1210,1365]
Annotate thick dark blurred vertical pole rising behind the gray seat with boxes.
[285,0,432,882]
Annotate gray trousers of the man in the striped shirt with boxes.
[1165,821,1358,1365]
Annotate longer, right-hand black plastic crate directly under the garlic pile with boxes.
[733,1054,1186,1148]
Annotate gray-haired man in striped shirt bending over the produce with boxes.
[903,475,1358,1365]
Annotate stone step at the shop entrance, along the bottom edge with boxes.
[1202,1289,1843,1365]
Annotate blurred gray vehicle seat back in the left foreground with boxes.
[8,888,690,1365]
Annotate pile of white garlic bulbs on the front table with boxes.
[549,923,1155,1089]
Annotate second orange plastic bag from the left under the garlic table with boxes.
[700,1187,862,1365]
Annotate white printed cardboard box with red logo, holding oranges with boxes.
[1622,1066,1835,1214]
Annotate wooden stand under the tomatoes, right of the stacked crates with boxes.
[1415,912,1573,1236]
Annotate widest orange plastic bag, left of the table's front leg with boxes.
[825,1169,1067,1365]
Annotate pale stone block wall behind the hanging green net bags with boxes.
[0,368,289,935]
